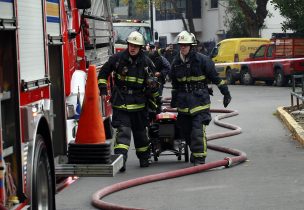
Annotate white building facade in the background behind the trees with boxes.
[154,0,284,46]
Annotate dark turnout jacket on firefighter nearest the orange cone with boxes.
[98,50,159,112]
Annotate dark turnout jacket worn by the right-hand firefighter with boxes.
[171,51,230,120]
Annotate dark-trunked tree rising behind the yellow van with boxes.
[224,0,269,37]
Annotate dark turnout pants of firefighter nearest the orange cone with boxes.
[112,109,150,161]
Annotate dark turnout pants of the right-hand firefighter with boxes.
[177,113,209,158]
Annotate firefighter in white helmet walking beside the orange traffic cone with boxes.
[98,31,159,172]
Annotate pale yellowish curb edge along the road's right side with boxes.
[277,107,304,145]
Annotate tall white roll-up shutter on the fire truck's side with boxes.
[17,0,46,82]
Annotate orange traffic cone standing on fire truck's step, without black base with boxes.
[75,65,106,144]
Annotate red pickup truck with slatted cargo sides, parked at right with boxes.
[241,38,304,86]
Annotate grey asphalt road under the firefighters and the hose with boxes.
[56,85,304,210]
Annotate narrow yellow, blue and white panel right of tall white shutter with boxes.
[46,0,61,41]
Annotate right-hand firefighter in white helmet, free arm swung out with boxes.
[171,31,231,165]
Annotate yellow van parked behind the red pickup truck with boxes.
[211,38,270,84]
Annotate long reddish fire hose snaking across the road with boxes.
[92,99,247,210]
